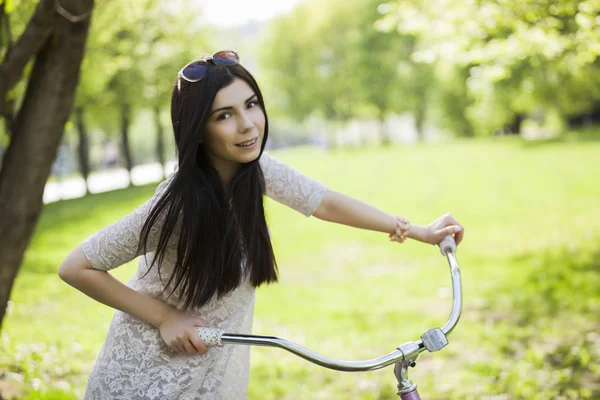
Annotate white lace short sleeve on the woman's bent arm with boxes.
[81,180,168,271]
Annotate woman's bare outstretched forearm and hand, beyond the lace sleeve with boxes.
[313,189,464,244]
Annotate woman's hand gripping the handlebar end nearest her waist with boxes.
[159,309,208,354]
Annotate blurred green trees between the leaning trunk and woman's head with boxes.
[74,0,208,184]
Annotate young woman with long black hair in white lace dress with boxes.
[59,51,463,400]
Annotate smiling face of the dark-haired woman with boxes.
[204,78,265,178]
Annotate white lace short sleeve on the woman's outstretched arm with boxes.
[260,152,327,217]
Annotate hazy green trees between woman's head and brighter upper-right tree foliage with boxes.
[260,0,422,130]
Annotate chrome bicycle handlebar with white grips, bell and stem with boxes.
[196,236,462,400]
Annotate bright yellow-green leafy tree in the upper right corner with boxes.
[382,0,600,134]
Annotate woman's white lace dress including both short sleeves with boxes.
[82,152,327,400]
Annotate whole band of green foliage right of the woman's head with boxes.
[260,0,600,136]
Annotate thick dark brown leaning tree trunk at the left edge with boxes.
[0,0,93,327]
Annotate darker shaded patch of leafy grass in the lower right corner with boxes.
[471,241,600,399]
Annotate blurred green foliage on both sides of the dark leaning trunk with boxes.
[0,0,209,168]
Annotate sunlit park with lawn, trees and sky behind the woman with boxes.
[0,0,600,400]
